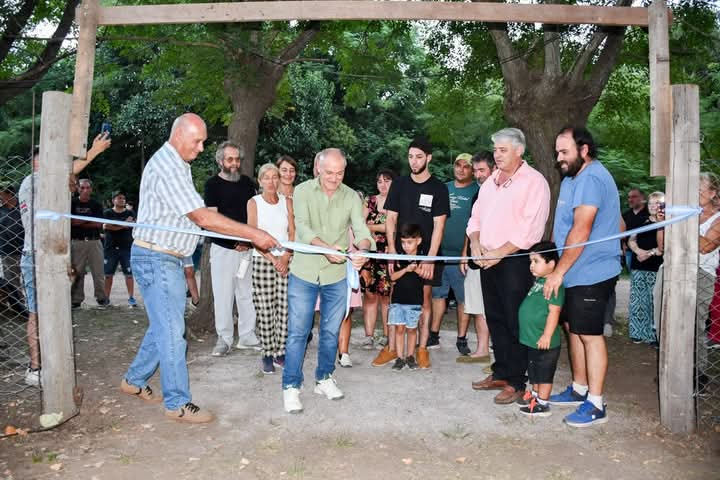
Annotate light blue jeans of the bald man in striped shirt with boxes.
[125,245,191,410]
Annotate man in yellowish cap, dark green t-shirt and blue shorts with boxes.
[427,153,480,355]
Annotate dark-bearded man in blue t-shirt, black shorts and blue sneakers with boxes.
[544,127,621,427]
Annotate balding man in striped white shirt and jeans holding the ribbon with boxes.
[120,113,279,423]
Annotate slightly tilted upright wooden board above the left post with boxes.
[69,0,99,158]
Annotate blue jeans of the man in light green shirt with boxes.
[282,274,347,389]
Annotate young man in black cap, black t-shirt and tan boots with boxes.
[373,138,450,369]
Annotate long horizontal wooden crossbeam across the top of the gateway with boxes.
[98,0,648,26]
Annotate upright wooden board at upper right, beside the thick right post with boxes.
[648,0,672,176]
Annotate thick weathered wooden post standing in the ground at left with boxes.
[34,92,77,418]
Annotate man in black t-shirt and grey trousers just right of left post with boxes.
[70,178,110,308]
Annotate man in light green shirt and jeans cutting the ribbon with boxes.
[282,148,375,413]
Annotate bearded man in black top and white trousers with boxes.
[205,142,260,357]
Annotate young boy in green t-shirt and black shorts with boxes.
[518,242,565,417]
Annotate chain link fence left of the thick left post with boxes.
[0,152,42,428]
